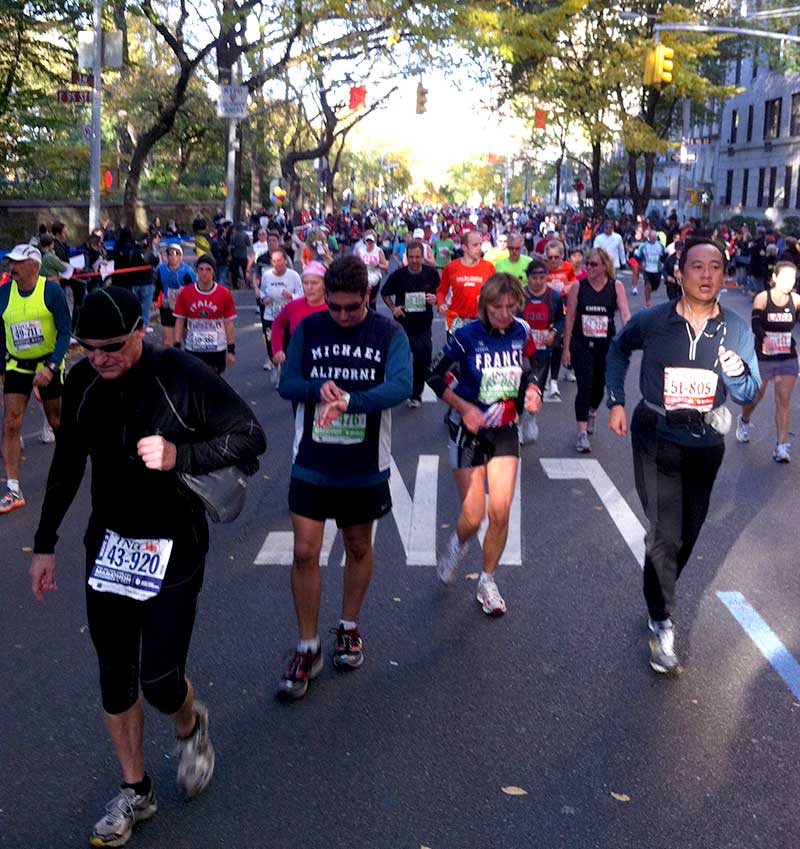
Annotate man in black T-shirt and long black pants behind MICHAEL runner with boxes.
[381,240,439,409]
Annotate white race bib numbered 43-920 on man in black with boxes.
[88,531,172,601]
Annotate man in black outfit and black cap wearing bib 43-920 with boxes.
[30,286,266,846]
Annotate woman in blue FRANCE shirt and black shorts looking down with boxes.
[428,274,542,616]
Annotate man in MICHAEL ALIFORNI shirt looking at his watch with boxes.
[278,256,411,699]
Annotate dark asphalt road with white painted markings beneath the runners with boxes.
[0,276,800,849]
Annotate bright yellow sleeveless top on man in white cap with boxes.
[2,277,58,374]
